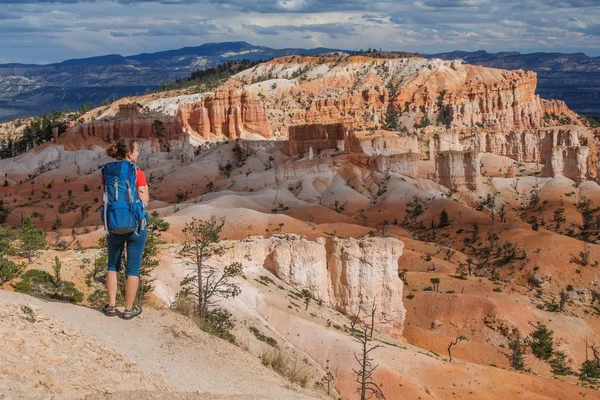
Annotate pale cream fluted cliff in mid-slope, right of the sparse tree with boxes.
[210,235,406,336]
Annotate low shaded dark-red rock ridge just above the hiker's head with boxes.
[69,114,185,143]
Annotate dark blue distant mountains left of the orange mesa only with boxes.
[0,42,339,122]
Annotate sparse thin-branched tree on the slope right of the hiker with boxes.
[181,216,242,318]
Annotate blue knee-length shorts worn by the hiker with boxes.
[106,229,146,276]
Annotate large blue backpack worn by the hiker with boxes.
[100,161,148,234]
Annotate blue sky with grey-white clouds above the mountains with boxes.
[0,0,600,64]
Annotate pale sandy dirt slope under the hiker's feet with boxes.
[0,290,318,399]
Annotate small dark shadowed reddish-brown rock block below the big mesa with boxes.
[284,123,346,156]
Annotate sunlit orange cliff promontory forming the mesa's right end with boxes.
[393,59,543,131]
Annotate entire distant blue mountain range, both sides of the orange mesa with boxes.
[0,42,600,121]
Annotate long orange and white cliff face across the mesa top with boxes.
[227,56,544,135]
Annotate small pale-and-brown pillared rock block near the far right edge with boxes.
[545,146,589,183]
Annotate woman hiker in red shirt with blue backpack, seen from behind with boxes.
[102,138,150,319]
